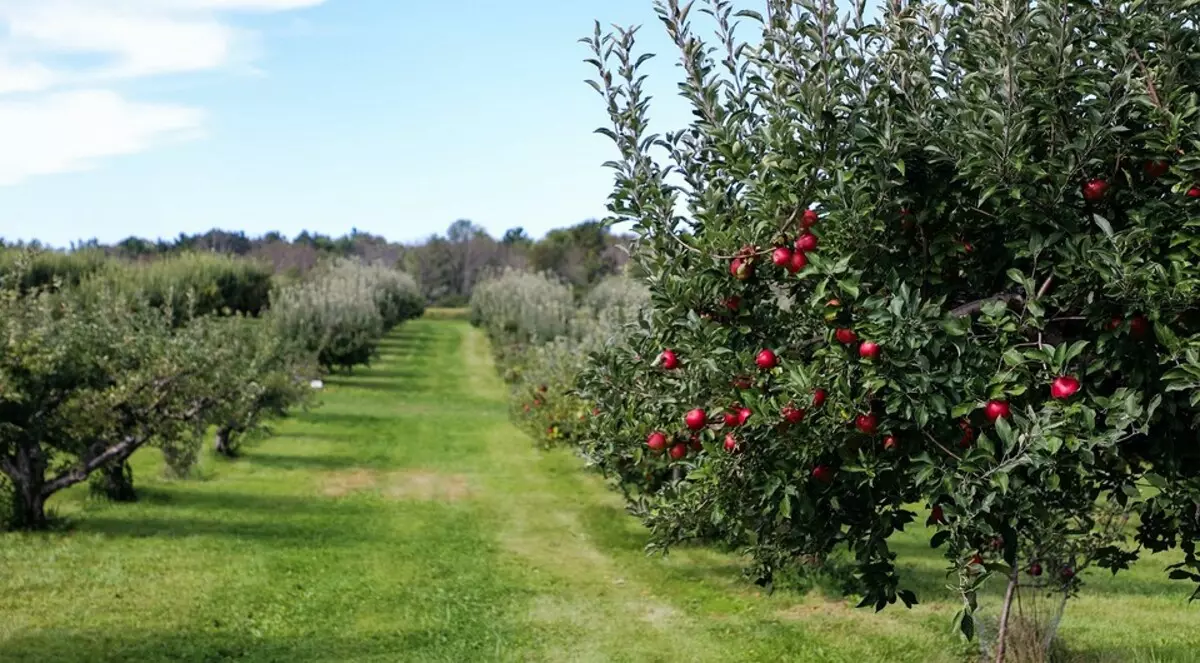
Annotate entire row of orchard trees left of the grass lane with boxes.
[0,250,424,528]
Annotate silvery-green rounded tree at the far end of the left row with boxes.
[270,259,425,369]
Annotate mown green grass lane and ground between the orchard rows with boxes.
[0,319,1200,663]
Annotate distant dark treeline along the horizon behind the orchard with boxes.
[0,220,630,306]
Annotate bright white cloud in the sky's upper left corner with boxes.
[0,0,324,185]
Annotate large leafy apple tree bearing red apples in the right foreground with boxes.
[576,0,1200,659]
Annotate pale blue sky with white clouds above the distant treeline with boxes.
[0,0,705,246]
